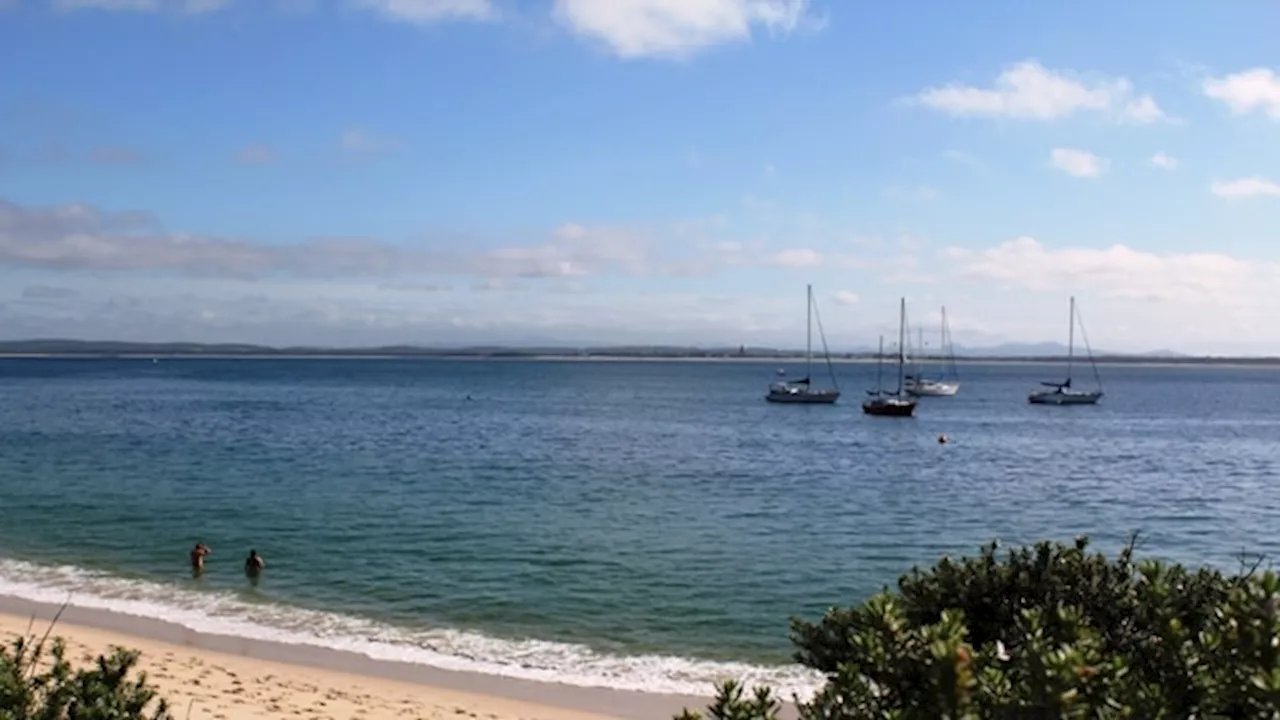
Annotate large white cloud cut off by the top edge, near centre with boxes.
[553,0,815,59]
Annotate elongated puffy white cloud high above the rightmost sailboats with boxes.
[914,60,1167,124]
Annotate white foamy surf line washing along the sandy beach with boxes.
[0,560,822,698]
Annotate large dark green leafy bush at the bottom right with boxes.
[680,538,1280,720]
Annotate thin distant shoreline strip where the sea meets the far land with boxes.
[0,350,1280,369]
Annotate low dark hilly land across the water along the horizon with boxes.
[0,340,1280,366]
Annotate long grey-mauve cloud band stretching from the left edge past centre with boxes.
[0,201,687,281]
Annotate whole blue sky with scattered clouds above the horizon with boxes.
[0,0,1280,355]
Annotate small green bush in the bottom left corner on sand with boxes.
[0,622,173,720]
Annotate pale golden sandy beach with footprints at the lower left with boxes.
[0,598,711,720]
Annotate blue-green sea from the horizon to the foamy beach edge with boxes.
[0,360,1280,693]
